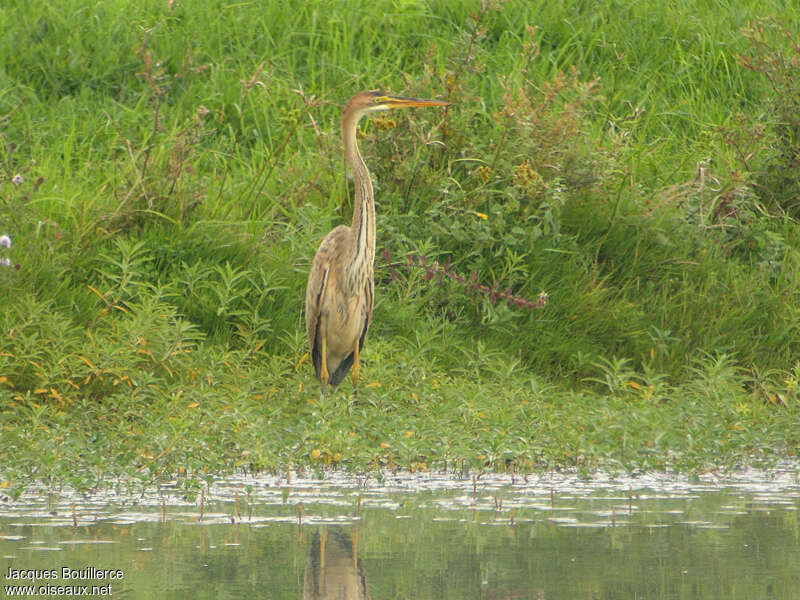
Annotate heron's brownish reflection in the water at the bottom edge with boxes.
[303,526,370,600]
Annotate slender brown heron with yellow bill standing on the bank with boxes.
[306,90,448,396]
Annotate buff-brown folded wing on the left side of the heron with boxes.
[306,225,350,377]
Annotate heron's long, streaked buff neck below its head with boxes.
[342,115,375,282]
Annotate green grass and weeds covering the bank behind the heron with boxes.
[0,0,800,491]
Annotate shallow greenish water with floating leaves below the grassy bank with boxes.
[0,465,800,600]
